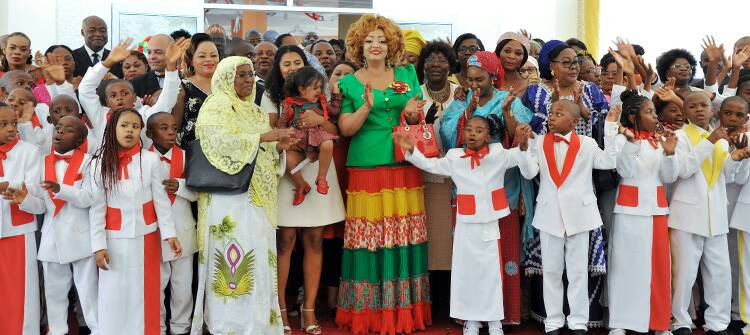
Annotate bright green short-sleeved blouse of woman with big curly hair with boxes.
[339,64,422,167]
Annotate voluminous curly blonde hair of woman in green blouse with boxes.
[346,14,404,67]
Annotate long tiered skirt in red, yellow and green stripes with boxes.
[336,166,432,335]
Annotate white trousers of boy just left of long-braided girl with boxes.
[42,256,99,335]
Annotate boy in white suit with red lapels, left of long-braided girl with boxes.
[32,115,99,335]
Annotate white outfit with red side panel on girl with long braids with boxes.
[84,149,175,335]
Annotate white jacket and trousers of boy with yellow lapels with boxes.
[668,127,740,331]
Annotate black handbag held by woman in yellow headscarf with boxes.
[185,140,255,194]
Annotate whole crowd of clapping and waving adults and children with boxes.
[0,11,750,335]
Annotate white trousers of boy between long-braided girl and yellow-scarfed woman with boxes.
[159,255,194,334]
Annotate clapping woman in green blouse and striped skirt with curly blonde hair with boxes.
[336,15,432,334]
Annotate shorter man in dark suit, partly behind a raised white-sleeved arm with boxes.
[130,34,174,97]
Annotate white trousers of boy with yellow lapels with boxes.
[669,229,732,331]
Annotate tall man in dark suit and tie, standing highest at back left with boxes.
[73,16,122,78]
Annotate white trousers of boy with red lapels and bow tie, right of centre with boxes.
[539,231,589,332]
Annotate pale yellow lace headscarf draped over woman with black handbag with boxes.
[195,56,279,230]
